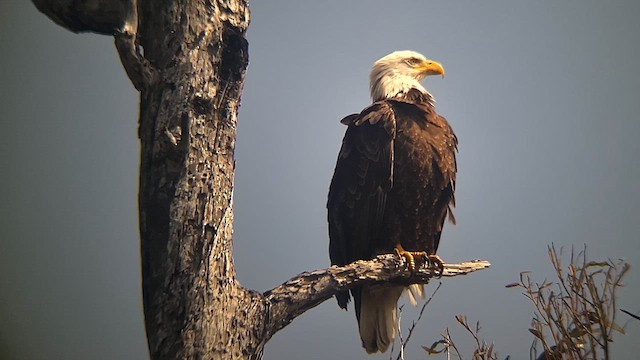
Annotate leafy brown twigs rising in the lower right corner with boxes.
[507,245,630,360]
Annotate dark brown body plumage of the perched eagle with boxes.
[327,89,457,336]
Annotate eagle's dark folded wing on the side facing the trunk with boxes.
[327,101,396,308]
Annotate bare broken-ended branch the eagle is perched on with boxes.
[264,254,491,339]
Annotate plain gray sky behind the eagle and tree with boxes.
[0,0,640,360]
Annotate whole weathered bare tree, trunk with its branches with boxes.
[33,0,489,359]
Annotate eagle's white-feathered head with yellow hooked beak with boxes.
[369,50,444,101]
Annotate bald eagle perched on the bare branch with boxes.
[327,51,458,353]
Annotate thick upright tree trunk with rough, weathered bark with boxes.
[133,1,266,359]
